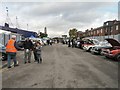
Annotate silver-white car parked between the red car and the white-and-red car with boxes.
[91,40,112,55]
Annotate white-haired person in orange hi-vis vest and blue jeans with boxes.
[6,35,21,68]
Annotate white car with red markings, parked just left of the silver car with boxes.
[83,39,99,51]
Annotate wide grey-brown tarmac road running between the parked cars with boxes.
[2,44,118,88]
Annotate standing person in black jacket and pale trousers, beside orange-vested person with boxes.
[23,38,33,64]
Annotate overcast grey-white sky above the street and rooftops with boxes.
[0,2,118,37]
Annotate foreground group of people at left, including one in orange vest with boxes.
[6,35,42,68]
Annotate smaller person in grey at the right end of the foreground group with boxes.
[34,41,42,63]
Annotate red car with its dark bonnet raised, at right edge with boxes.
[102,38,120,61]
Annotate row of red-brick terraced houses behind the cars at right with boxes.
[77,20,120,41]
